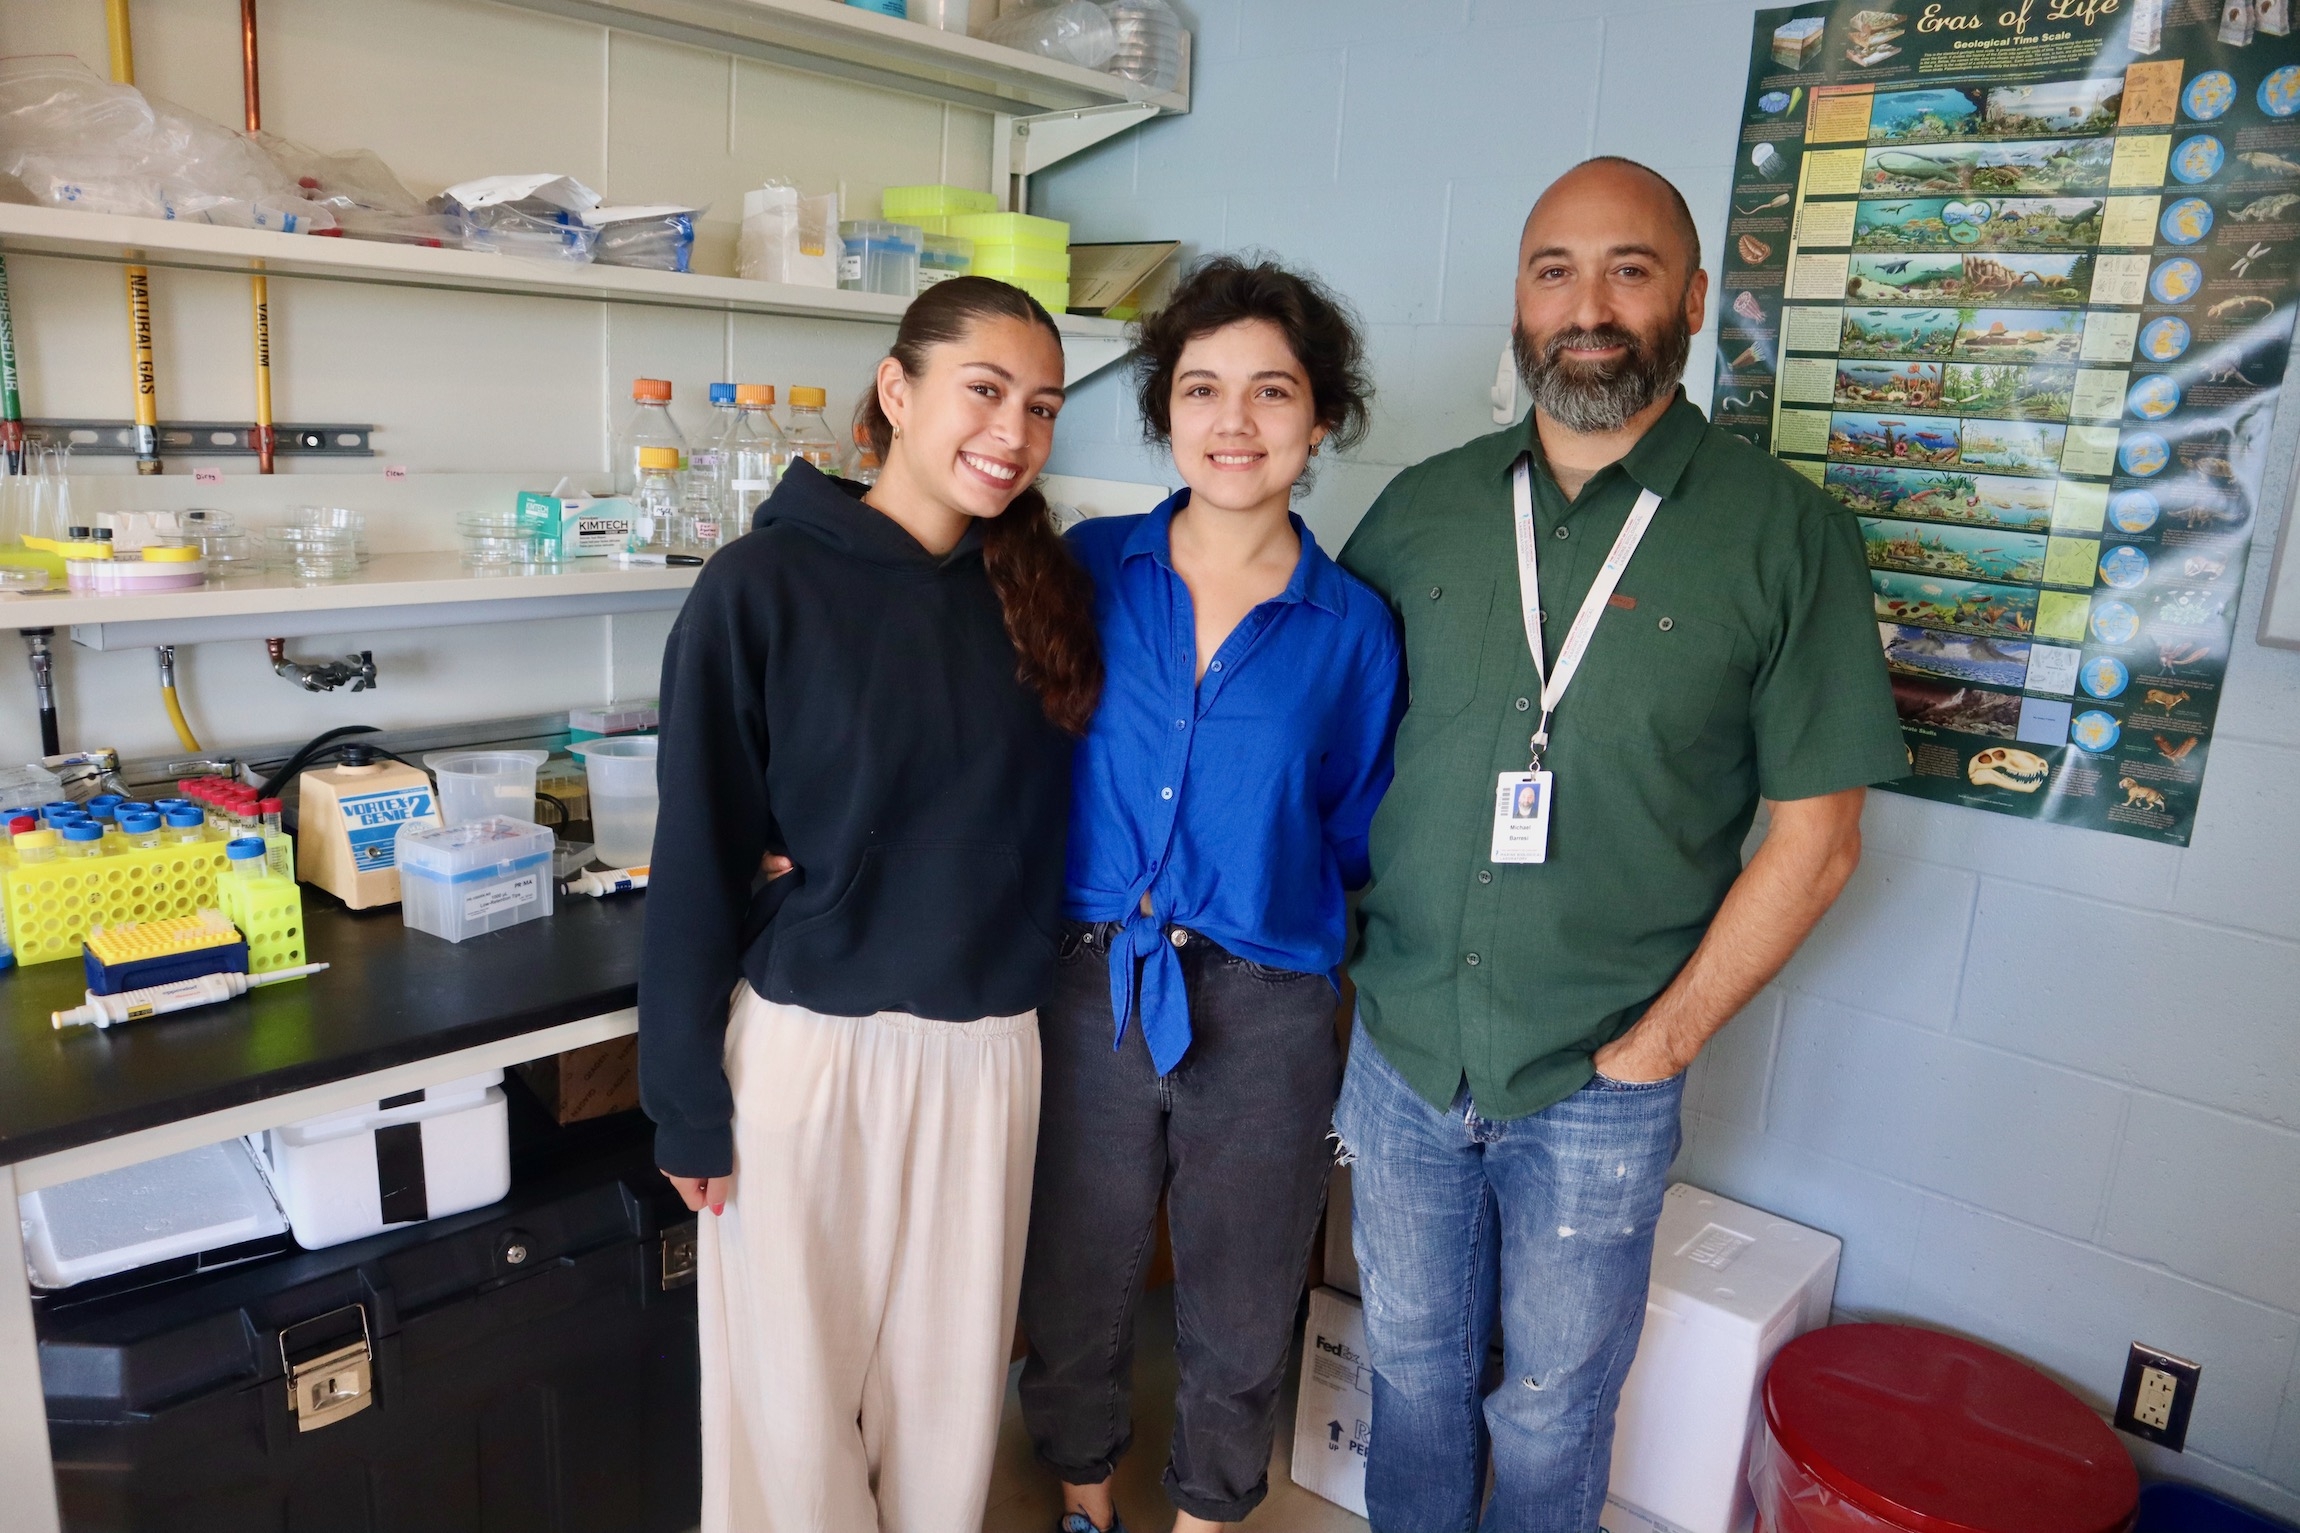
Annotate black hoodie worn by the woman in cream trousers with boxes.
[639,462,1070,1177]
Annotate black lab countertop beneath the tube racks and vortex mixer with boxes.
[0,885,646,1163]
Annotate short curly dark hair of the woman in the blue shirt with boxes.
[1134,255,1373,450]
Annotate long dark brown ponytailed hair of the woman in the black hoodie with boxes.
[856,276,1102,735]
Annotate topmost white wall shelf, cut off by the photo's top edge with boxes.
[478,0,1189,115]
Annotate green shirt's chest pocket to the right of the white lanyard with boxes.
[1553,609,1732,752]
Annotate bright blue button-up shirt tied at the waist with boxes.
[1067,490,1403,1076]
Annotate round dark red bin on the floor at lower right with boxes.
[1748,1326,2141,1533]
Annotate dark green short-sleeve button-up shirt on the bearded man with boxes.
[1341,398,1909,1117]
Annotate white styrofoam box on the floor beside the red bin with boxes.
[1605,1181,1842,1533]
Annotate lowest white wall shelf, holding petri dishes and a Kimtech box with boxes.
[0,552,697,650]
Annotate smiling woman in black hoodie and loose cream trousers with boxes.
[639,278,1102,1533]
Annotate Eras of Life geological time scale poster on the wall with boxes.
[1714,0,2300,846]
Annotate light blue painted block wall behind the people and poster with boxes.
[1033,0,2300,1519]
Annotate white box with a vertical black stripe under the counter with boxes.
[248,1071,511,1250]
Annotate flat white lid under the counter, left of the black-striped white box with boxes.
[16,1140,288,1287]
